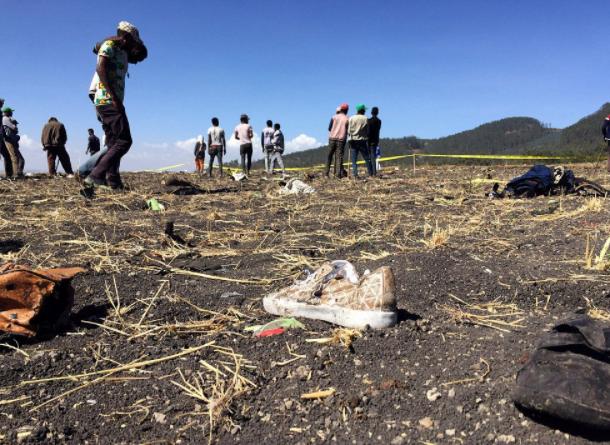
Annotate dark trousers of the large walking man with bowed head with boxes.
[89,105,133,187]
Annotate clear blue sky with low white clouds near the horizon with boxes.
[0,0,610,169]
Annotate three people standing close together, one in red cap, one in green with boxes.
[325,103,381,178]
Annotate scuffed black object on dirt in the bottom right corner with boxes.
[513,315,610,434]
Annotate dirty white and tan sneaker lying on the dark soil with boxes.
[263,261,398,329]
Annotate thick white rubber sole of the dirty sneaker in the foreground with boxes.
[263,297,398,329]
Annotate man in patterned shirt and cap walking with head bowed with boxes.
[83,22,147,196]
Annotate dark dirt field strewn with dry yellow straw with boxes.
[0,165,610,445]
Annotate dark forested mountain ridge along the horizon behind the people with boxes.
[256,103,610,167]
